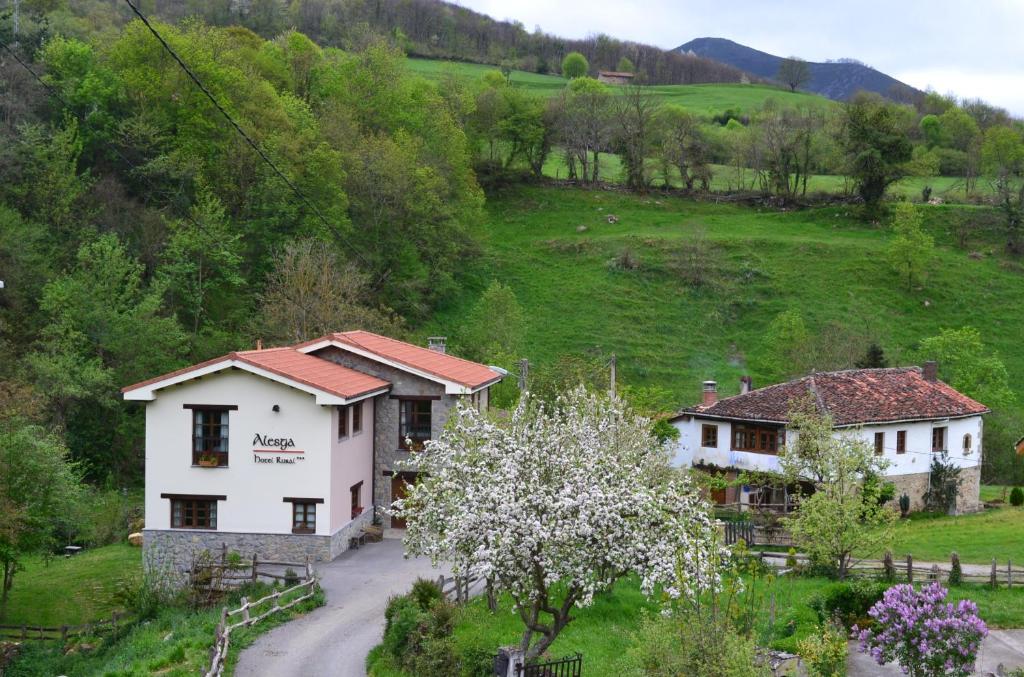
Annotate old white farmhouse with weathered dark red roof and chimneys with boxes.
[672,363,989,511]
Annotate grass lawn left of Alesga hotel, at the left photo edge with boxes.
[2,545,142,627]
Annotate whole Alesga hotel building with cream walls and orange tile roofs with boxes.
[123,331,502,566]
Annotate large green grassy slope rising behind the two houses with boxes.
[426,183,1024,405]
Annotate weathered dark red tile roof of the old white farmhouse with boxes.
[679,367,989,426]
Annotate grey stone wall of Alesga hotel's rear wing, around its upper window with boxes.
[314,347,460,527]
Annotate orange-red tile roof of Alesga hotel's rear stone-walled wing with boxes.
[305,331,501,388]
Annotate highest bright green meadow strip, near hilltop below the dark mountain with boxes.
[406,58,836,116]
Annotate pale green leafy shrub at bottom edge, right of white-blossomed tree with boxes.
[625,613,769,677]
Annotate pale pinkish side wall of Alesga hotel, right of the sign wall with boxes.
[329,398,374,534]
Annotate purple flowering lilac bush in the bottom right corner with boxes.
[853,583,988,677]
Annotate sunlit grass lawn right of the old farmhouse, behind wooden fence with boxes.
[876,506,1024,566]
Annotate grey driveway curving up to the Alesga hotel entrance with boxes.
[234,539,449,677]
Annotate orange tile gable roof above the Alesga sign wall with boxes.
[121,347,391,399]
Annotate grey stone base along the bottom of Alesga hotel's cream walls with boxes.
[142,510,373,578]
